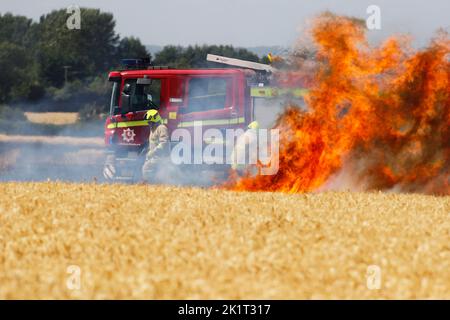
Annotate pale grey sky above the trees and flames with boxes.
[0,0,450,47]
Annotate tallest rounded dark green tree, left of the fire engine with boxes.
[37,8,119,87]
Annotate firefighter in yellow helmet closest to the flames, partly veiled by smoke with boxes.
[231,121,259,174]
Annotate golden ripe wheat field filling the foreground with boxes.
[0,182,450,299]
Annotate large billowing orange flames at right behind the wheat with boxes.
[229,13,450,195]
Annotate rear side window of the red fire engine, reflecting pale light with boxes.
[187,78,228,112]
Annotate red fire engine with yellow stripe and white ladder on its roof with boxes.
[103,55,304,181]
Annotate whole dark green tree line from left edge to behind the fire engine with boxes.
[0,8,262,113]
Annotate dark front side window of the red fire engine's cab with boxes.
[120,79,161,111]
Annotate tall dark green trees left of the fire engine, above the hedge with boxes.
[0,8,149,109]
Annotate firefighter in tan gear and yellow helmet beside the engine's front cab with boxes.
[142,109,169,181]
